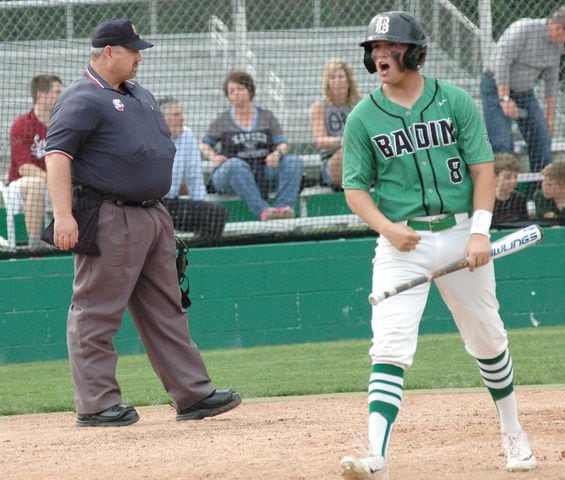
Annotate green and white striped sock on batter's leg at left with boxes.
[369,363,404,457]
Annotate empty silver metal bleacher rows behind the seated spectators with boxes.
[0,26,478,165]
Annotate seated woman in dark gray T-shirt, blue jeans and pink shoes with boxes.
[200,70,303,220]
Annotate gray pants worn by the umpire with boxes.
[67,202,214,414]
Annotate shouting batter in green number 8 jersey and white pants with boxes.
[341,11,536,479]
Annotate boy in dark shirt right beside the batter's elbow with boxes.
[492,153,528,225]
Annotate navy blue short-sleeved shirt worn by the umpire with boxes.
[45,66,176,202]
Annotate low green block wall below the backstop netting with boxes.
[0,228,565,364]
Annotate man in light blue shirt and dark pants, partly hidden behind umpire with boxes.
[159,97,228,237]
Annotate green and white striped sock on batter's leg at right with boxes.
[477,349,522,433]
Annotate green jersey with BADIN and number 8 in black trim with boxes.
[343,77,494,222]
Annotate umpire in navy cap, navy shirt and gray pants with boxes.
[42,19,241,427]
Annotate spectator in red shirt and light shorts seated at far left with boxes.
[8,75,63,250]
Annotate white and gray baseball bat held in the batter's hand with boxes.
[369,225,543,305]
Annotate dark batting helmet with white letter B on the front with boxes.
[359,11,428,73]
